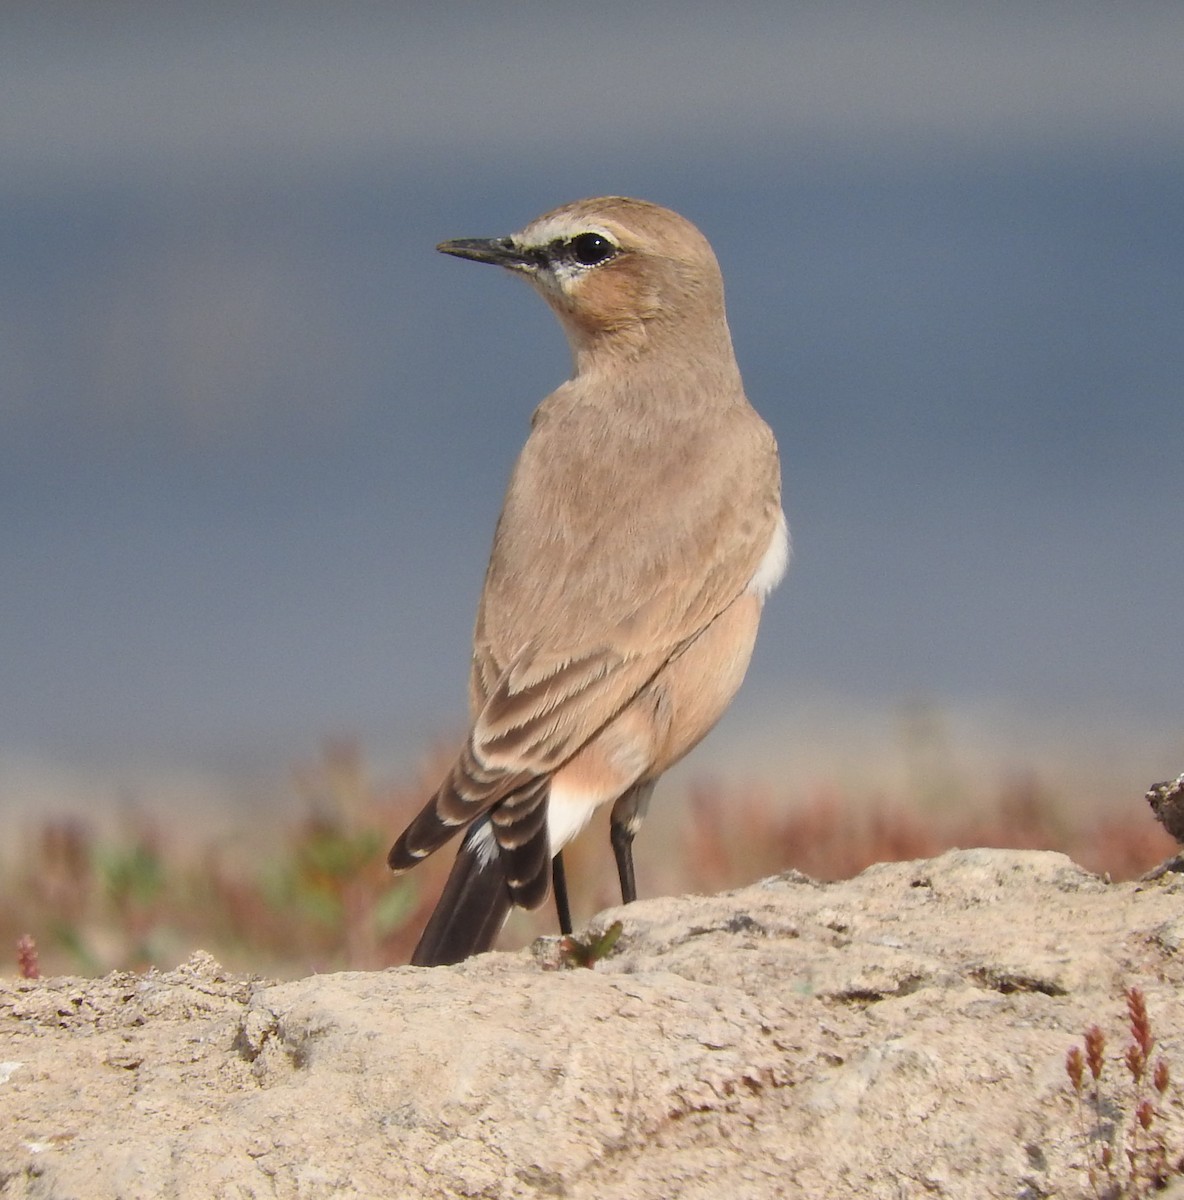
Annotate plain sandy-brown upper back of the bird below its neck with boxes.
[476,364,780,686]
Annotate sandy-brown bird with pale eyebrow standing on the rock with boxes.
[387,196,789,966]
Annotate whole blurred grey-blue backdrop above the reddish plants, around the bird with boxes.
[0,0,1184,965]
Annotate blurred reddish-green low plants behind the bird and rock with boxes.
[0,742,1174,977]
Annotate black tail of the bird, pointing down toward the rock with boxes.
[411,822,510,967]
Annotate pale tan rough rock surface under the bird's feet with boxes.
[0,850,1184,1200]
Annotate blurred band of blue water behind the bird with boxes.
[0,9,1184,777]
